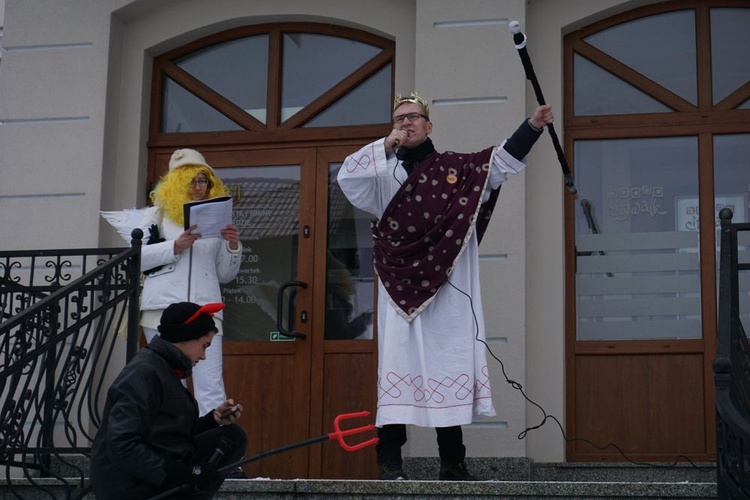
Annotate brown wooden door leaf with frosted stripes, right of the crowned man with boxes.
[566,136,716,463]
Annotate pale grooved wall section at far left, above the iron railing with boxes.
[0,0,117,250]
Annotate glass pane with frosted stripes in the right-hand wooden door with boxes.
[575,137,702,341]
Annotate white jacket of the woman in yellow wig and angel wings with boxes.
[141,218,242,319]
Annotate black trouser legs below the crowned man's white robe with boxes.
[375,424,466,463]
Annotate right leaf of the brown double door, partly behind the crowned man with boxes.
[310,147,377,479]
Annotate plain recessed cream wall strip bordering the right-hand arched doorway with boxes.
[525,0,654,462]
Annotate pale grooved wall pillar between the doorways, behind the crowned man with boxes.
[408,0,525,457]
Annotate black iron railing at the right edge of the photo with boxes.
[713,208,750,499]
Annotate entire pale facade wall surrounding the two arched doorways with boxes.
[0,0,650,461]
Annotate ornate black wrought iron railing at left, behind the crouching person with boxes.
[0,230,143,498]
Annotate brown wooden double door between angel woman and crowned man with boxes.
[197,148,376,479]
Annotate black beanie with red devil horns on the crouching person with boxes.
[159,302,225,343]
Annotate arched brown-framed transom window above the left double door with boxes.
[151,23,394,143]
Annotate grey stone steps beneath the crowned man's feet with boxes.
[0,458,717,500]
